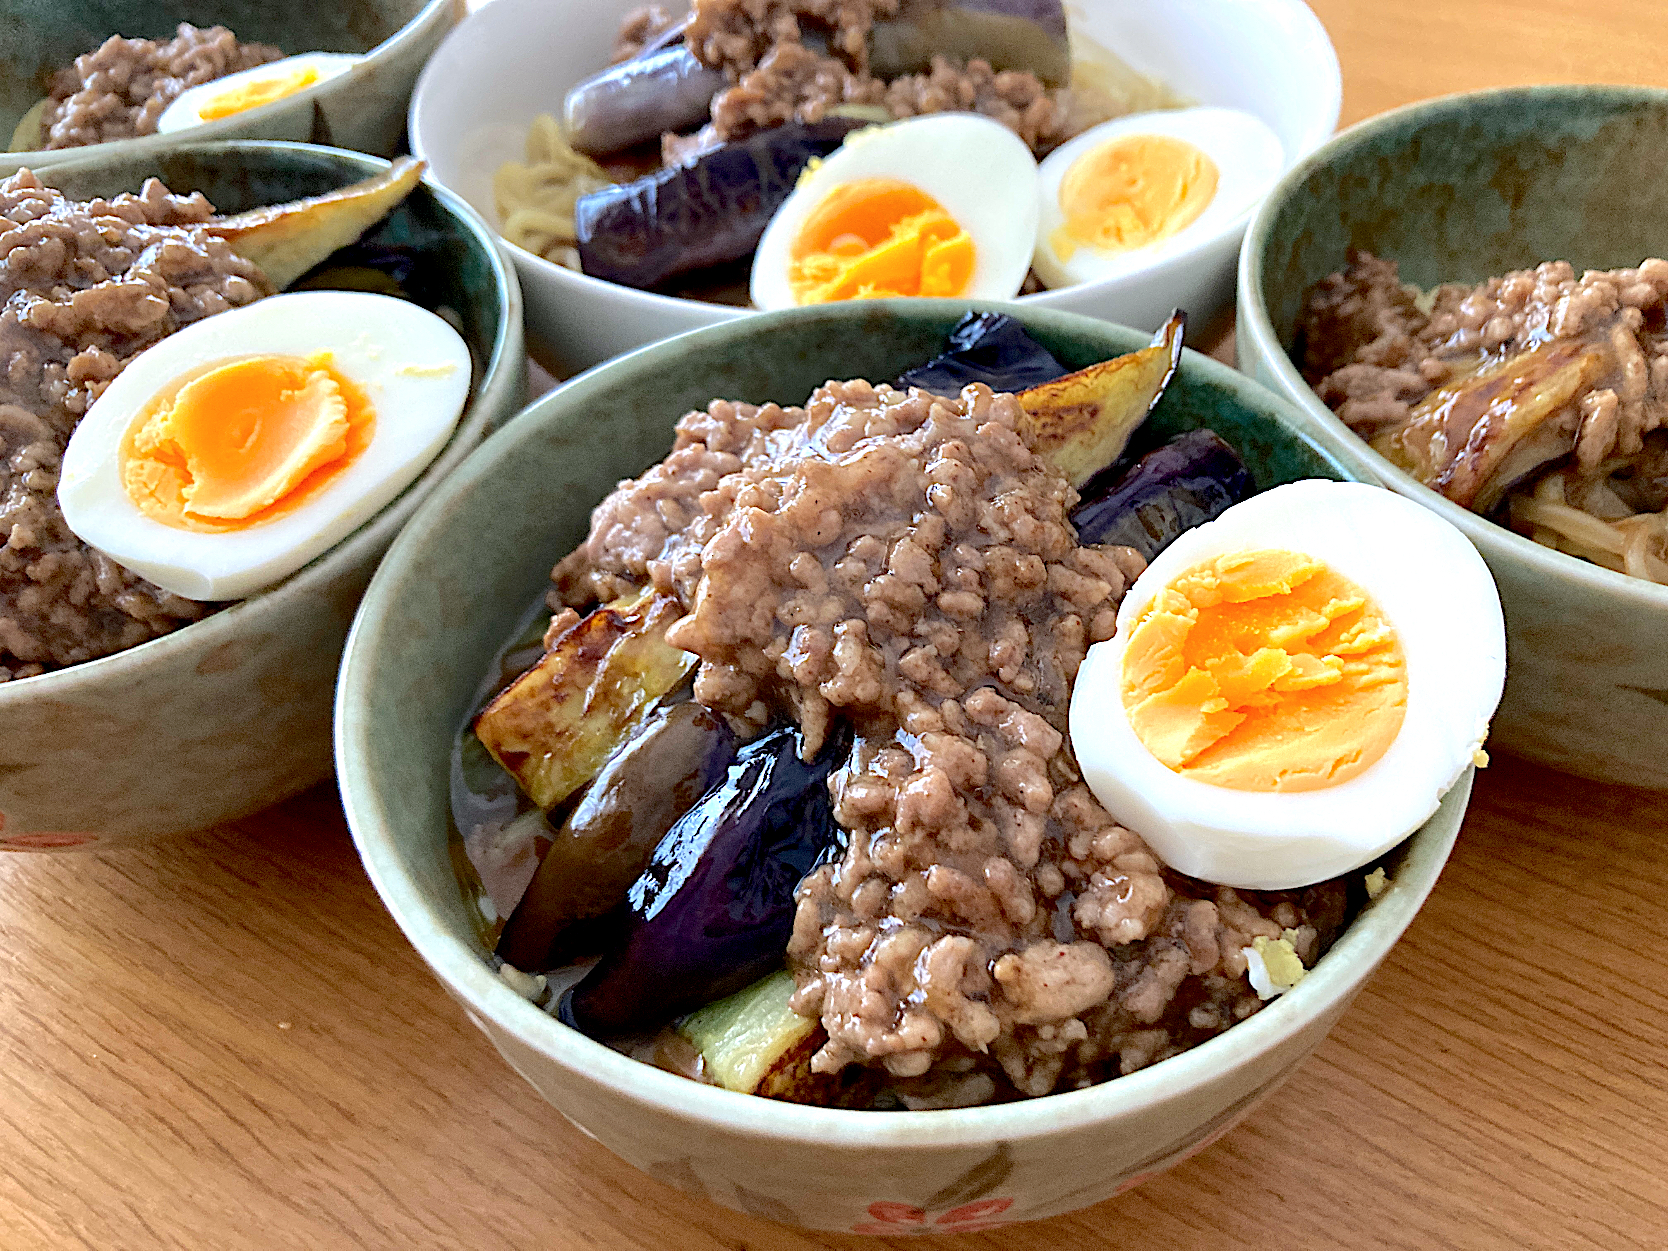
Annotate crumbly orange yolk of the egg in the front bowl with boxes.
[1121,550,1408,791]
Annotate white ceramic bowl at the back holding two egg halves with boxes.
[410,0,1339,374]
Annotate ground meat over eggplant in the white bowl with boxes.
[660,0,1078,163]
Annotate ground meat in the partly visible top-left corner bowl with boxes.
[40,22,284,148]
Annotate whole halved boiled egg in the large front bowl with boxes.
[1069,480,1506,891]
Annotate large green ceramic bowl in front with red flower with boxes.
[337,300,1470,1233]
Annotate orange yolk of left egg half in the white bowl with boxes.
[787,178,974,304]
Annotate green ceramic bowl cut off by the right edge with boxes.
[1239,87,1668,789]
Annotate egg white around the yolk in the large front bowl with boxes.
[1069,479,1506,891]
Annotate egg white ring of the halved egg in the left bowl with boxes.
[58,290,470,600]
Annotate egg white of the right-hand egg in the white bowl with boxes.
[1031,108,1286,287]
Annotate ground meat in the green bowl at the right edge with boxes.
[1298,252,1668,510]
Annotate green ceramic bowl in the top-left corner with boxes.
[0,0,464,173]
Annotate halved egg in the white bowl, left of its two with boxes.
[751,113,1037,309]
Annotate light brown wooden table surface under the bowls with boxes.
[0,0,1668,1251]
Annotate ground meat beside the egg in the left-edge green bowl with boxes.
[0,170,269,682]
